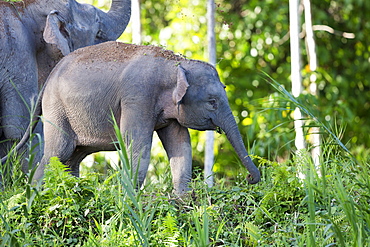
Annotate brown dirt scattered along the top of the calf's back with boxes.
[74,41,187,62]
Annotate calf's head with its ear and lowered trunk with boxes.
[173,61,261,184]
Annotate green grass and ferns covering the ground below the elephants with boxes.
[0,76,370,247]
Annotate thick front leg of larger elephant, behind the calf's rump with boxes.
[0,58,42,172]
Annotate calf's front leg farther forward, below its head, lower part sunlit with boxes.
[157,122,192,195]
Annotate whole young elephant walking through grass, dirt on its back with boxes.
[34,42,260,195]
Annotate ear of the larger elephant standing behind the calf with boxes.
[43,10,71,56]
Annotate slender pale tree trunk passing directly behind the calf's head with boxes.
[204,0,216,187]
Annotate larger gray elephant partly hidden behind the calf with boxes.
[0,0,131,176]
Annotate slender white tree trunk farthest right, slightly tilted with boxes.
[303,0,321,169]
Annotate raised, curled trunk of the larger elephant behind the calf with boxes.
[102,0,131,40]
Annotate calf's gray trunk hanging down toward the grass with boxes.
[214,106,261,184]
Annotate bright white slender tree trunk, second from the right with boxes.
[289,0,306,152]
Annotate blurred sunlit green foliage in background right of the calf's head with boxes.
[214,0,370,152]
